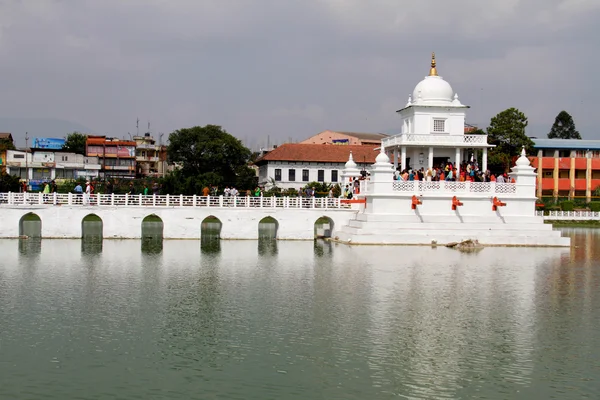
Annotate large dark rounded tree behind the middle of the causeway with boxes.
[166,125,255,194]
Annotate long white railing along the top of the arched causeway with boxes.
[0,192,351,209]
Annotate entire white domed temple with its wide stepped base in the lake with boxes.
[335,53,570,246]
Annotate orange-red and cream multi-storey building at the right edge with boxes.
[530,138,600,202]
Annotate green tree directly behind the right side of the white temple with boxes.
[487,108,533,172]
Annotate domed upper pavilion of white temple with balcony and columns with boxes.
[382,54,493,174]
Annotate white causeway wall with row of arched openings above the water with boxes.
[0,205,356,240]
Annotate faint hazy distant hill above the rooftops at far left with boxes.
[0,117,94,147]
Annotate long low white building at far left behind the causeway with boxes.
[7,150,100,190]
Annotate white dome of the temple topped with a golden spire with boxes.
[411,53,460,106]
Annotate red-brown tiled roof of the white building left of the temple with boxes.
[255,143,378,165]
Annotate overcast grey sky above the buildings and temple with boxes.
[0,0,600,146]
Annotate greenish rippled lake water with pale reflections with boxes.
[0,229,600,400]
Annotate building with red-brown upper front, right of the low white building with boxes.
[85,136,136,179]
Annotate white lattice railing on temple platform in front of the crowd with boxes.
[392,181,517,194]
